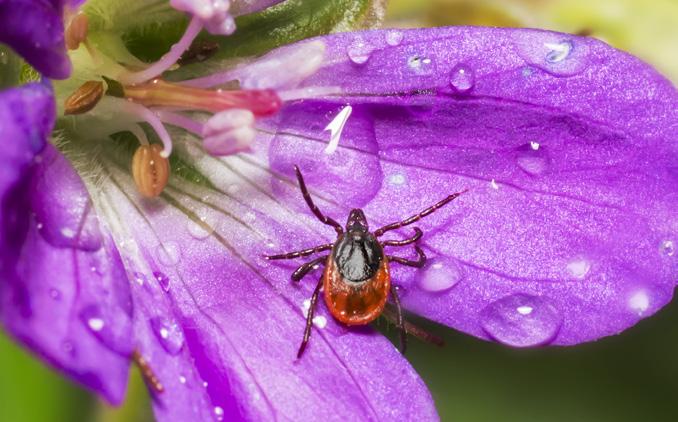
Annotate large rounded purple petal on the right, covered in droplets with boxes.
[251,28,678,346]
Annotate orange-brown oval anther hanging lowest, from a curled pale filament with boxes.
[132,144,170,198]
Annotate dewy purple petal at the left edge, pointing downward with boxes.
[0,90,133,403]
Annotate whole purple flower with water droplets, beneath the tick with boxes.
[0,2,678,421]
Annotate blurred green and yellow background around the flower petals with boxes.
[0,0,678,422]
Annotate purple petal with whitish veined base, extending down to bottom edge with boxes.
[94,161,437,421]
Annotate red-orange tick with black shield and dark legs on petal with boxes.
[265,166,466,358]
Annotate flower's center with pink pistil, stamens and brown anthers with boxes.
[57,8,283,196]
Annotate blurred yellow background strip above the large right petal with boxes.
[385,0,678,84]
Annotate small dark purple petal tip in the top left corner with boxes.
[0,0,72,79]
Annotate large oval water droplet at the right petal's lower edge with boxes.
[480,294,563,347]
